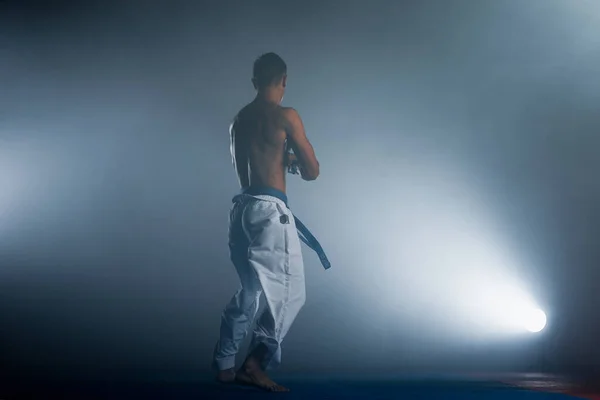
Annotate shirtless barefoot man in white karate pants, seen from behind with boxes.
[214,53,319,391]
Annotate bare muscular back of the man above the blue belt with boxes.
[230,101,287,193]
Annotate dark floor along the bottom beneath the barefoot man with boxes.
[0,374,600,400]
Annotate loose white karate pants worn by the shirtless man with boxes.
[214,194,306,370]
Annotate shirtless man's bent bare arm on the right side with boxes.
[283,108,319,181]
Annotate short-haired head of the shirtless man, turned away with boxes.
[252,53,287,103]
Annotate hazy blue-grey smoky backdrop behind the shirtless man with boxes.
[0,0,600,382]
